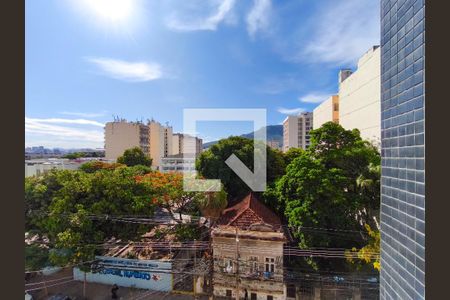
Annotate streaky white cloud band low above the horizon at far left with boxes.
[25,117,104,148]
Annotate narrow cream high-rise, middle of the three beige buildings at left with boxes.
[148,120,173,169]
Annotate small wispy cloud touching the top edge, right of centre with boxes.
[247,0,272,37]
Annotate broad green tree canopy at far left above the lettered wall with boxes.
[25,167,155,265]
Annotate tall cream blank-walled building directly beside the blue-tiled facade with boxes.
[340,46,381,145]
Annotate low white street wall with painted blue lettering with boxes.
[73,256,172,292]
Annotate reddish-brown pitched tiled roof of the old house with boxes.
[217,193,281,230]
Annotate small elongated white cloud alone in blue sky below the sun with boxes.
[87,57,163,82]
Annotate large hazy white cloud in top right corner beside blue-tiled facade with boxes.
[294,0,380,65]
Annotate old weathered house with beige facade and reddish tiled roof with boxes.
[211,193,287,300]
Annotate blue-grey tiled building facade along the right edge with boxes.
[380,0,425,299]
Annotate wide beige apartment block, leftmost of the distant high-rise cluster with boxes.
[105,120,150,160]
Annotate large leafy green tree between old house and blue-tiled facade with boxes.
[278,122,380,268]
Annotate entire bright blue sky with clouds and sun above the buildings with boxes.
[25,0,379,148]
